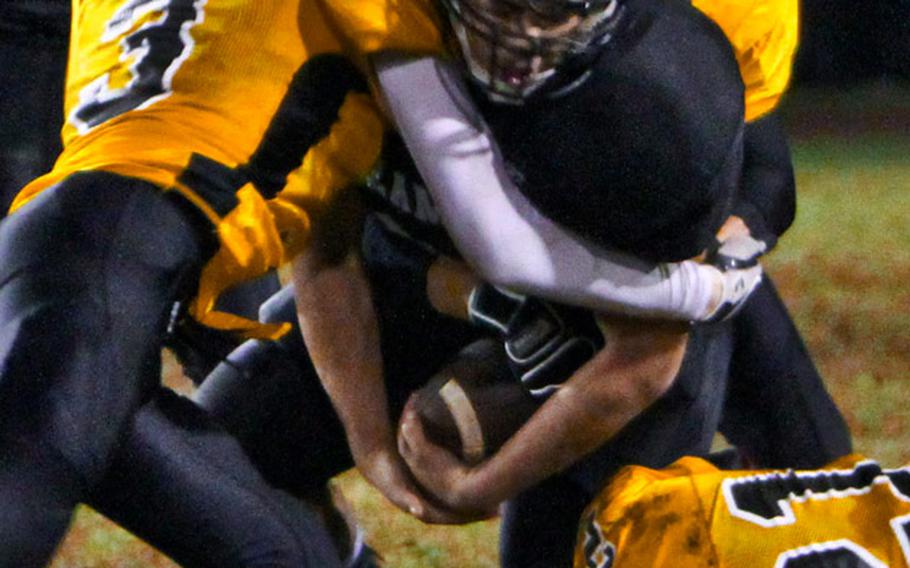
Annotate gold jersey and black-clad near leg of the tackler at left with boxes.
[0,0,444,566]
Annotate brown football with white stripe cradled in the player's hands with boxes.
[412,339,540,464]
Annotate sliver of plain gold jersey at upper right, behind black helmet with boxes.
[692,0,799,122]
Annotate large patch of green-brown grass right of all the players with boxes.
[767,132,910,465]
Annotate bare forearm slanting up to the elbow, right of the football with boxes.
[465,322,687,503]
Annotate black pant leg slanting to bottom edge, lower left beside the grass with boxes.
[86,388,341,568]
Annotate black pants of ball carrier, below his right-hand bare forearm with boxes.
[499,323,732,568]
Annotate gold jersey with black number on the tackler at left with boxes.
[13,0,439,336]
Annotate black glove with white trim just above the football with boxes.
[468,284,604,398]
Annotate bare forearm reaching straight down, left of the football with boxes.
[292,254,394,462]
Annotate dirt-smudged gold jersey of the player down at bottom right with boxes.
[574,456,910,568]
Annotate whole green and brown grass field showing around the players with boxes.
[53,88,910,568]
